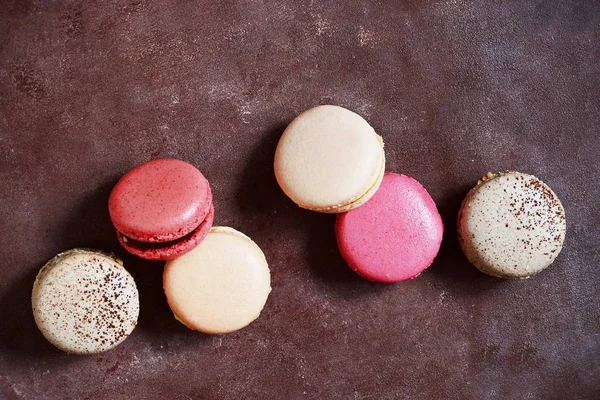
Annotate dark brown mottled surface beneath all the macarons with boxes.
[0,0,600,400]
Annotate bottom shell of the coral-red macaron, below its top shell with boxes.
[117,202,215,261]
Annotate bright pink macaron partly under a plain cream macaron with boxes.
[335,172,444,283]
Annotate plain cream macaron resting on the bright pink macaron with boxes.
[274,105,385,213]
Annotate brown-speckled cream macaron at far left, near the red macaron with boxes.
[31,249,139,354]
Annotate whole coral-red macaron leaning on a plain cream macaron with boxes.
[108,158,214,260]
